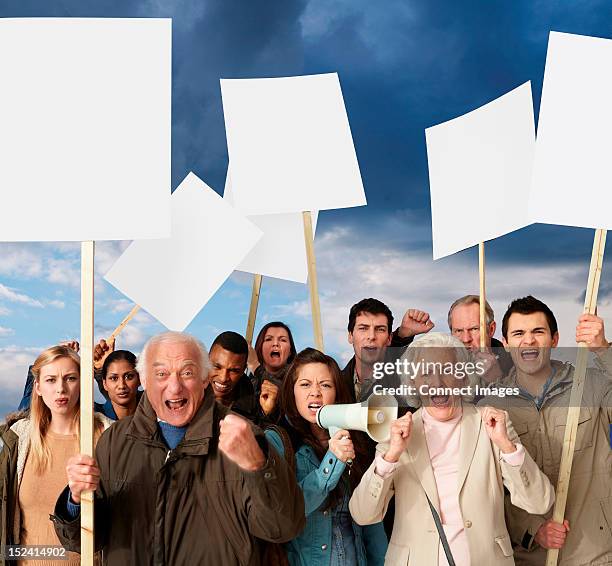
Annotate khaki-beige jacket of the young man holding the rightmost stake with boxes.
[480,348,612,566]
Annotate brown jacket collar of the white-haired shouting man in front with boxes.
[126,387,217,456]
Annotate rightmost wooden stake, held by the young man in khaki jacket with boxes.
[546,230,606,566]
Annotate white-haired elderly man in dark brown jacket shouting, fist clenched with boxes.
[52,332,305,565]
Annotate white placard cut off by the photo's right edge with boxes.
[529,32,612,230]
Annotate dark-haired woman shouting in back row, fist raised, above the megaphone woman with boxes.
[249,321,296,418]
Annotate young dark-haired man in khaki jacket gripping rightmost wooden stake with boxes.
[480,296,612,566]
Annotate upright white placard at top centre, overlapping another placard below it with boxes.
[221,73,366,215]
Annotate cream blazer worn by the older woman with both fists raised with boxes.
[350,405,554,566]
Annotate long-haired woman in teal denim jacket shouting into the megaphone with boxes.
[266,348,387,566]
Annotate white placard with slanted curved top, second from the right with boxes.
[425,82,535,259]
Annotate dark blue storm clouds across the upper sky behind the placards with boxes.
[0,0,612,262]
